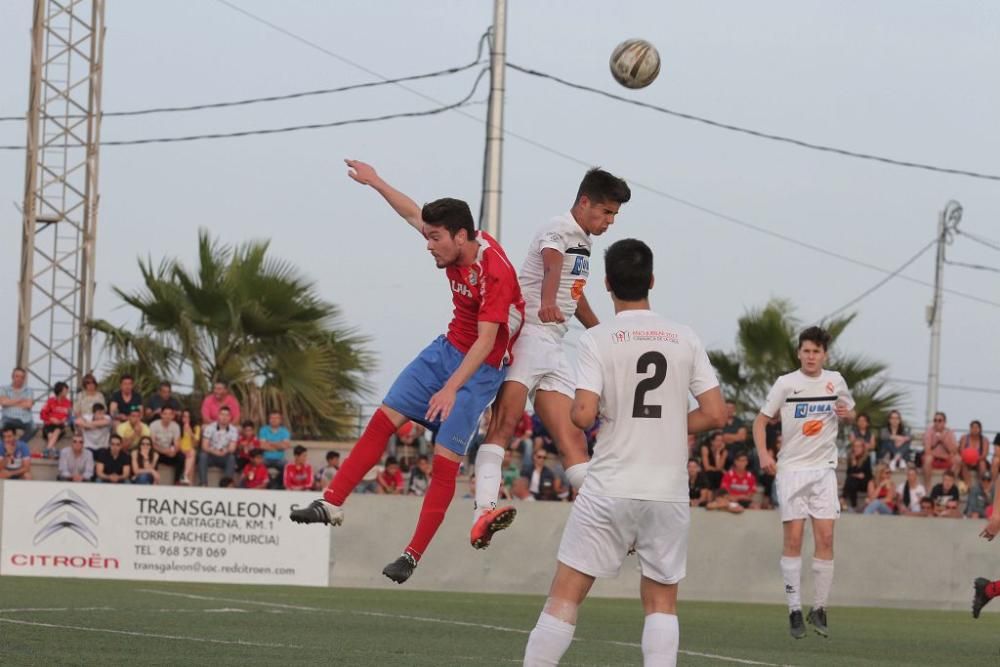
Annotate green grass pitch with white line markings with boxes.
[0,577,1000,667]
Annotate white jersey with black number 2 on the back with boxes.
[576,310,719,503]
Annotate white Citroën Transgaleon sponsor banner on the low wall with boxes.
[0,481,330,586]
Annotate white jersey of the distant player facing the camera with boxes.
[760,370,854,470]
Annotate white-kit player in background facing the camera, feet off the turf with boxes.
[753,327,854,639]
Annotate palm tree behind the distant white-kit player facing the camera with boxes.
[708,299,905,423]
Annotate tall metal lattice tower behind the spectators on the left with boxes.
[17,0,104,389]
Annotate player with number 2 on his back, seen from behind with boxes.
[524,239,726,667]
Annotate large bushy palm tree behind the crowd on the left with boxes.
[92,230,374,435]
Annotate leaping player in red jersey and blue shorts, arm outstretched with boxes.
[291,160,524,584]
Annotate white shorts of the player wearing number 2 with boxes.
[559,492,691,584]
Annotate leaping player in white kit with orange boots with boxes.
[469,168,632,549]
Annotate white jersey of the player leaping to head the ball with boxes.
[517,213,591,337]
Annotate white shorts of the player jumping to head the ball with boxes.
[504,324,576,398]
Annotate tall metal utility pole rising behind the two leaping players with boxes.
[480,0,507,241]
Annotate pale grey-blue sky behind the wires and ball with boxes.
[0,0,1000,433]
